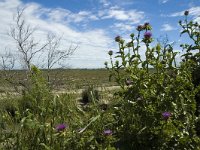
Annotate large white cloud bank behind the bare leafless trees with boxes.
[0,0,113,68]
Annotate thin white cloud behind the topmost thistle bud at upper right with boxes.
[170,6,200,23]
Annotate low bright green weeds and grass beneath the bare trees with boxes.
[0,66,114,150]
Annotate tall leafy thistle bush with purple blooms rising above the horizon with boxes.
[106,15,200,149]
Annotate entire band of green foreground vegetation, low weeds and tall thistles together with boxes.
[0,11,200,150]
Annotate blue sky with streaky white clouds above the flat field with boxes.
[0,0,200,68]
